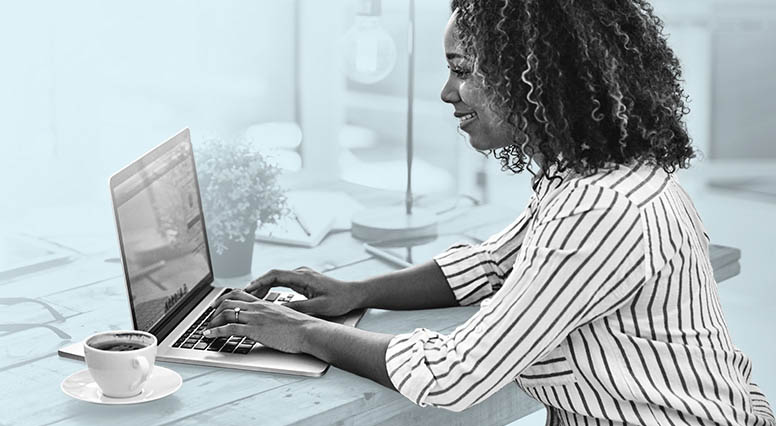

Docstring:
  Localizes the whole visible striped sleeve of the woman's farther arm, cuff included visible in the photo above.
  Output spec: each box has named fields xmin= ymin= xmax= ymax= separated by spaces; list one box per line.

xmin=434 ymin=206 xmax=531 ymax=306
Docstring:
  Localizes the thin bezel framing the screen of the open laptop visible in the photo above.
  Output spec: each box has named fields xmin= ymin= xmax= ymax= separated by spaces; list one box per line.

xmin=110 ymin=128 xmax=213 ymax=341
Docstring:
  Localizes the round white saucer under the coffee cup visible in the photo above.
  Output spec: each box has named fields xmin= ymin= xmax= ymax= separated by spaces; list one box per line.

xmin=60 ymin=365 xmax=183 ymax=405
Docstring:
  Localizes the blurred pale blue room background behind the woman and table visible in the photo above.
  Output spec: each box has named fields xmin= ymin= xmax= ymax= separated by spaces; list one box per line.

xmin=0 ymin=0 xmax=776 ymax=420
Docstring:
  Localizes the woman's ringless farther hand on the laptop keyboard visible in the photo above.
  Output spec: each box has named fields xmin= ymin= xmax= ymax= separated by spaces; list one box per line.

xmin=245 ymin=266 xmax=361 ymax=317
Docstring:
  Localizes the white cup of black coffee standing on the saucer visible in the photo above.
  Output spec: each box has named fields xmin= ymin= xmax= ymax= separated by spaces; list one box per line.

xmin=84 ymin=330 xmax=157 ymax=398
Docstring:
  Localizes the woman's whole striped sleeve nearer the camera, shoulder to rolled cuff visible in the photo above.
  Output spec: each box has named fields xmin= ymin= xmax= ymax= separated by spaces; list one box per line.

xmin=386 ymin=185 xmax=647 ymax=411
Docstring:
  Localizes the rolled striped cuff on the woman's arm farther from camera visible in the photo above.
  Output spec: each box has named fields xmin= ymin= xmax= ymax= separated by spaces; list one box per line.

xmin=434 ymin=245 xmax=502 ymax=306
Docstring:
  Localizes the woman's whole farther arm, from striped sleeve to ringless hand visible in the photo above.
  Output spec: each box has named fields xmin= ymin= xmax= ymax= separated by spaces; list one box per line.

xmin=245 ymin=205 xmax=531 ymax=316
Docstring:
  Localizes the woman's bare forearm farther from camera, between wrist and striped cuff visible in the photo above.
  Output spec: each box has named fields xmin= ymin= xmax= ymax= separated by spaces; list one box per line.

xmin=356 ymin=261 xmax=458 ymax=310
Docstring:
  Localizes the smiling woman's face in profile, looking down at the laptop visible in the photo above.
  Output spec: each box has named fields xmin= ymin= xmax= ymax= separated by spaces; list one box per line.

xmin=441 ymin=11 xmax=513 ymax=151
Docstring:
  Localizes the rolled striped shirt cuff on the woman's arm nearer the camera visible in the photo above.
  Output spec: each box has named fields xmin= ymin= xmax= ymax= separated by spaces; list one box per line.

xmin=385 ymin=328 xmax=440 ymax=407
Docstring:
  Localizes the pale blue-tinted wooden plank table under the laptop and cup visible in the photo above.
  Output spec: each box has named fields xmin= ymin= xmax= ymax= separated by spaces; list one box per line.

xmin=0 ymin=201 xmax=740 ymax=425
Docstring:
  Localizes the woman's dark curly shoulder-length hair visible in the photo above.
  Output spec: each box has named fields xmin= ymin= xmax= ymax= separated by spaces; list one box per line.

xmin=451 ymin=0 xmax=695 ymax=179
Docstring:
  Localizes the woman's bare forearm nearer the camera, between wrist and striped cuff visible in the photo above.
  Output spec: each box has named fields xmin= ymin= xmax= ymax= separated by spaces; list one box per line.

xmin=303 ymin=319 xmax=395 ymax=390
